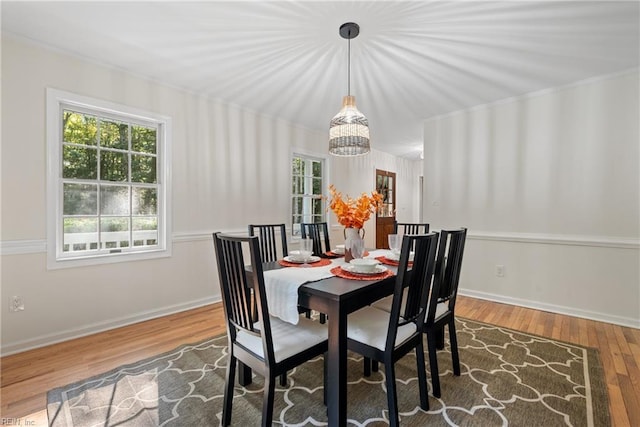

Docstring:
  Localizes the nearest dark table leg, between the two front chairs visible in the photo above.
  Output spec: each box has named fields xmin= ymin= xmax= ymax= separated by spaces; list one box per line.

xmin=327 ymin=307 xmax=347 ymax=427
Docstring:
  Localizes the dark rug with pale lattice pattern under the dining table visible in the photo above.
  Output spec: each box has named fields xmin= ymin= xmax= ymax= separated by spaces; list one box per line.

xmin=47 ymin=319 xmax=610 ymax=427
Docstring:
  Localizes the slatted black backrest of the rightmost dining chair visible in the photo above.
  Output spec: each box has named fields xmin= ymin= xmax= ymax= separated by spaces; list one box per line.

xmin=427 ymin=228 xmax=467 ymax=323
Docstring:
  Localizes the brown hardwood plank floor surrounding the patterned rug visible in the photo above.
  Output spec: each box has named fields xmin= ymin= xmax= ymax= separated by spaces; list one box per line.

xmin=0 ymin=297 xmax=640 ymax=427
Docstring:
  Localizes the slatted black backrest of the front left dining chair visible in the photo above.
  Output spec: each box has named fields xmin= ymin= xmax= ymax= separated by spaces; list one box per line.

xmin=213 ymin=233 xmax=274 ymax=361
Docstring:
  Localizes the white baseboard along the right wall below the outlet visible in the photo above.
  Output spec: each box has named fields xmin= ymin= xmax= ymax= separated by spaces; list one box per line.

xmin=458 ymin=288 xmax=640 ymax=329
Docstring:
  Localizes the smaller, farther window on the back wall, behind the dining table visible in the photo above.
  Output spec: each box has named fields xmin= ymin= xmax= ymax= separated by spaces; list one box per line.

xmin=291 ymin=154 xmax=327 ymax=236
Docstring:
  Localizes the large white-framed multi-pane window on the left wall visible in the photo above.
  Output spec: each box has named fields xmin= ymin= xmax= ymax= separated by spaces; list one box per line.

xmin=47 ymin=89 xmax=171 ymax=268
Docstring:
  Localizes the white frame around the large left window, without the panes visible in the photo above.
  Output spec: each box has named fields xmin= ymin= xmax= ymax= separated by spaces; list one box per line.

xmin=46 ymin=88 xmax=172 ymax=269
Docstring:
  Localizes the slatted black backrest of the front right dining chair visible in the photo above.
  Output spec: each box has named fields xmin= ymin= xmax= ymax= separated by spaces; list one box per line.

xmin=387 ymin=233 xmax=438 ymax=352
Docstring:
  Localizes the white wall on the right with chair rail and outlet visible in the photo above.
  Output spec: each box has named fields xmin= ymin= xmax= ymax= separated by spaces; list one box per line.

xmin=424 ymin=70 xmax=640 ymax=327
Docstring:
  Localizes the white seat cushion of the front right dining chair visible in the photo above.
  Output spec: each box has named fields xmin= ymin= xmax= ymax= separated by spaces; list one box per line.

xmin=347 ymin=307 xmax=416 ymax=351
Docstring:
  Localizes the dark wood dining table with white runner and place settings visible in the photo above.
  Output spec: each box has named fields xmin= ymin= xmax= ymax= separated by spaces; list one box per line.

xmin=238 ymin=250 xmax=397 ymax=427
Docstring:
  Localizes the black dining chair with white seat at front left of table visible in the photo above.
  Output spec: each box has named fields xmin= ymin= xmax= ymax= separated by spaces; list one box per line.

xmin=213 ymin=233 xmax=328 ymax=427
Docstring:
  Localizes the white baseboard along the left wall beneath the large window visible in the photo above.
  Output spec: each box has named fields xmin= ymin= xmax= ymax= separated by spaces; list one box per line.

xmin=0 ymin=297 xmax=221 ymax=357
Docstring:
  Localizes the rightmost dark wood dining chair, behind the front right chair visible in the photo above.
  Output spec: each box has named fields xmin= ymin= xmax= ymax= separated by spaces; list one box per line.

xmin=422 ymin=228 xmax=467 ymax=397
